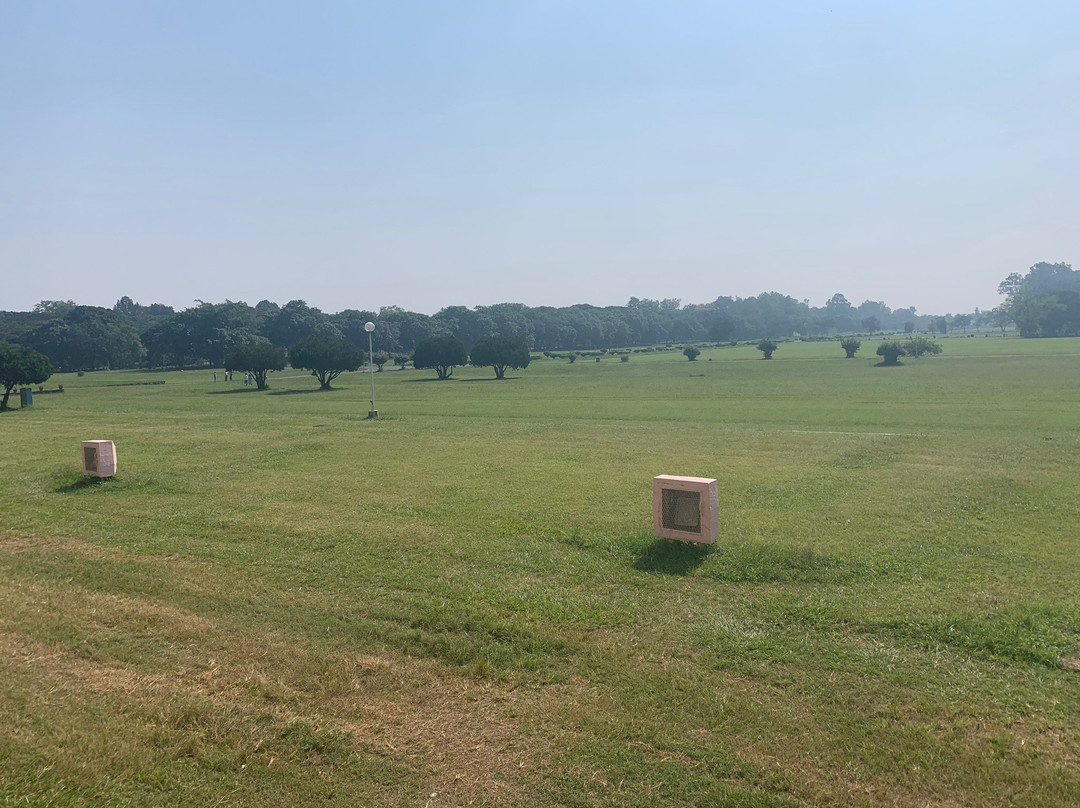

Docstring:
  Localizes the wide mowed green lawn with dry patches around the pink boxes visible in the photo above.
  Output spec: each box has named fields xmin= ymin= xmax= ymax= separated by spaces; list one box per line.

xmin=0 ymin=336 xmax=1080 ymax=807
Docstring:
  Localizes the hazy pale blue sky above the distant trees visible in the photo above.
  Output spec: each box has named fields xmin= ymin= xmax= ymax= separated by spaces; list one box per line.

xmin=0 ymin=0 xmax=1080 ymax=314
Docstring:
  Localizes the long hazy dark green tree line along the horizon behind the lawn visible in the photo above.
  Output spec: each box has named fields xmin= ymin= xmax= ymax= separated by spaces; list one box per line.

xmin=0 ymin=264 xmax=1080 ymax=371
